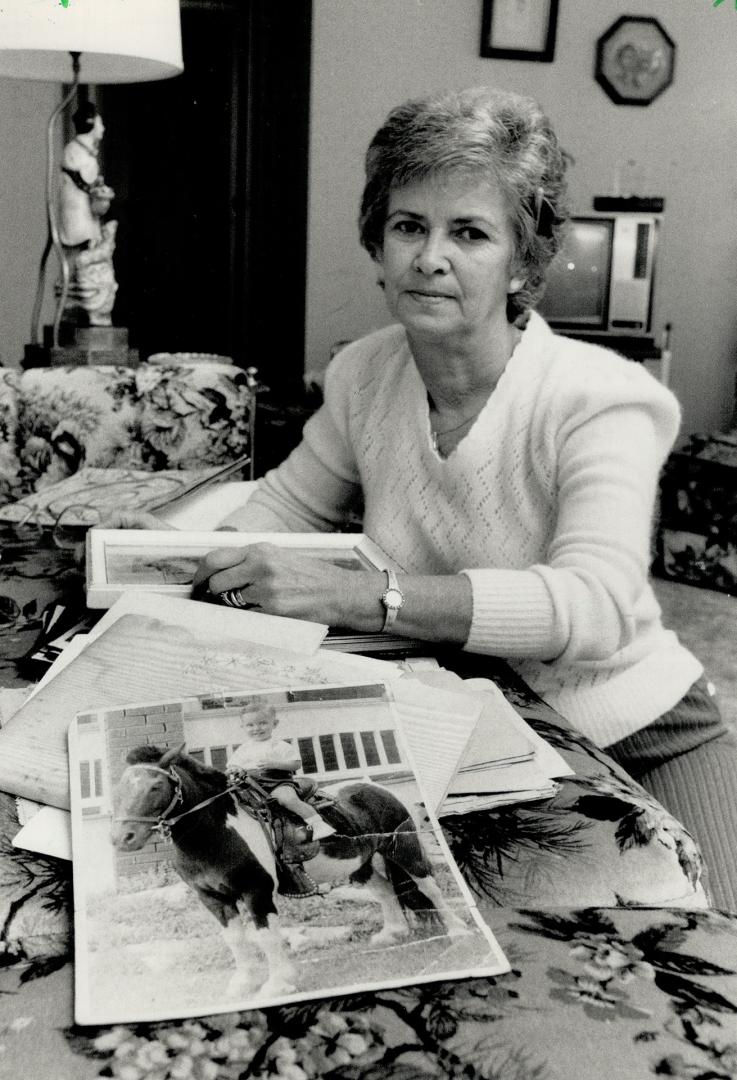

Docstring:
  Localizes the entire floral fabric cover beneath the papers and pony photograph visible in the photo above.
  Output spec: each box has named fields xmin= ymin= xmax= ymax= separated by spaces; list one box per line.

xmin=0 ymin=527 xmax=737 ymax=1080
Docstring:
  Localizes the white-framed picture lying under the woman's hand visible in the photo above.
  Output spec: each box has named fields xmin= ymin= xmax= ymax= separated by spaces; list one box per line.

xmin=85 ymin=529 xmax=401 ymax=608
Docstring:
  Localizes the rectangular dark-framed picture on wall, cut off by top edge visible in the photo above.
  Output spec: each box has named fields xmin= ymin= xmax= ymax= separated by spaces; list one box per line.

xmin=481 ymin=0 xmax=558 ymax=64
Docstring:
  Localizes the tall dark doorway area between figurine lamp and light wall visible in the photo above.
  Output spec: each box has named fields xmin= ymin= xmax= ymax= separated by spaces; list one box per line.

xmin=95 ymin=0 xmax=311 ymax=390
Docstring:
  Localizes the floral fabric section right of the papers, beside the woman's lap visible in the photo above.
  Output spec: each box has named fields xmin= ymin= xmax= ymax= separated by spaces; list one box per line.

xmin=434 ymin=653 xmax=709 ymax=917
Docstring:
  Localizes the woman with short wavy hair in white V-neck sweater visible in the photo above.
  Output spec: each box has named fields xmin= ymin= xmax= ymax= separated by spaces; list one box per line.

xmin=135 ymin=89 xmax=737 ymax=906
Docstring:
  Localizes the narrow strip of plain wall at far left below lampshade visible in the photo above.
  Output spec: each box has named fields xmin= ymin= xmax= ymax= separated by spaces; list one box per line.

xmin=0 ymin=79 xmax=61 ymax=367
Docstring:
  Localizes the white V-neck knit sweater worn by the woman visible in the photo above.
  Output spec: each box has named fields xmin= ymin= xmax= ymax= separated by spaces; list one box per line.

xmin=228 ymin=313 xmax=702 ymax=746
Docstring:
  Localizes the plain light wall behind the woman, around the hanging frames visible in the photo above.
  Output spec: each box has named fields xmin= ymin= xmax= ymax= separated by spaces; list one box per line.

xmin=306 ymin=0 xmax=737 ymax=431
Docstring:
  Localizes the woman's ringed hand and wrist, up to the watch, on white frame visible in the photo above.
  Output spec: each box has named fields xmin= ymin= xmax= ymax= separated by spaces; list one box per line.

xmin=193 ymin=543 xmax=383 ymax=629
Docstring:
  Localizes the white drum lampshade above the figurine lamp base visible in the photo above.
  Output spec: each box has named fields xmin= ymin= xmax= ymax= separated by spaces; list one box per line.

xmin=0 ymin=0 xmax=184 ymax=83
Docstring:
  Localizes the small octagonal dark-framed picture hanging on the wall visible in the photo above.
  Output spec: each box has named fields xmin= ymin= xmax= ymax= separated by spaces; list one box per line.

xmin=595 ymin=15 xmax=675 ymax=105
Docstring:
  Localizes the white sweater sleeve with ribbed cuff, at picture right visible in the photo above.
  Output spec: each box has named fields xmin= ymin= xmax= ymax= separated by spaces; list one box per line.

xmin=463 ymin=383 xmax=679 ymax=662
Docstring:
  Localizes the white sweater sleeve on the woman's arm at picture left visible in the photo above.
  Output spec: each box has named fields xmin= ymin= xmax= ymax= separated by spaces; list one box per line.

xmin=222 ymin=357 xmax=361 ymax=532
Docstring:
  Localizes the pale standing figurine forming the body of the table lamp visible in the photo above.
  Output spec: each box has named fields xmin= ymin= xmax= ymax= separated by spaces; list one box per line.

xmin=57 ymin=102 xmax=118 ymax=326
